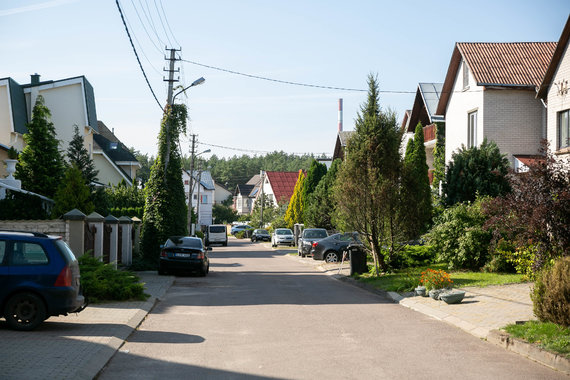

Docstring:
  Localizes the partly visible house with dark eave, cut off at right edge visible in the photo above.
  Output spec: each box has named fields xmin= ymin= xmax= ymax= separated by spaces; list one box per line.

xmin=537 ymin=17 xmax=570 ymax=158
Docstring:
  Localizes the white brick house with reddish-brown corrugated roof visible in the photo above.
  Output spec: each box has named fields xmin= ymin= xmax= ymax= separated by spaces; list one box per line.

xmin=435 ymin=42 xmax=556 ymax=167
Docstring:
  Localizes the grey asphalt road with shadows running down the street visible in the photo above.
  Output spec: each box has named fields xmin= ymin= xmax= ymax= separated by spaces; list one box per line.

xmin=99 ymin=240 xmax=568 ymax=380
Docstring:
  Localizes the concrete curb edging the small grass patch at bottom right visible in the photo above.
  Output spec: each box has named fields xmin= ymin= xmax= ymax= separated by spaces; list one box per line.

xmin=487 ymin=330 xmax=570 ymax=375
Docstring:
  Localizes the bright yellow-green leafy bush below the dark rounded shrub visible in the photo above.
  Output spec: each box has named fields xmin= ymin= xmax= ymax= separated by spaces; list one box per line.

xmin=425 ymin=198 xmax=491 ymax=269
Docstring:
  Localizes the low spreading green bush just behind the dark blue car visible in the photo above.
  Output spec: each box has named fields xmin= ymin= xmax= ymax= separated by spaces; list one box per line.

xmin=78 ymin=255 xmax=149 ymax=303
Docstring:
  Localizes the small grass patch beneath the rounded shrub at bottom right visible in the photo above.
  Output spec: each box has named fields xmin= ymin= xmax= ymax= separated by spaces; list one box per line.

xmin=504 ymin=321 xmax=570 ymax=359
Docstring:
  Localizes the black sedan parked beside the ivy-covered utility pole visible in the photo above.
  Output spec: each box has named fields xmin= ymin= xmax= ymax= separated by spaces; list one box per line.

xmin=158 ymin=236 xmax=212 ymax=276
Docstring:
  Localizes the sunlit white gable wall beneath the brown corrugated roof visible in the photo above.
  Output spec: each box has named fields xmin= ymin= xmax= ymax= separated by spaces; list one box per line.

xmin=445 ymin=63 xmax=484 ymax=164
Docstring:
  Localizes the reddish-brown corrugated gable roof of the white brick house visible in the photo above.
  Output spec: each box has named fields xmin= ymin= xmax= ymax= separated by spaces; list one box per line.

xmin=436 ymin=42 xmax=556 ymax=115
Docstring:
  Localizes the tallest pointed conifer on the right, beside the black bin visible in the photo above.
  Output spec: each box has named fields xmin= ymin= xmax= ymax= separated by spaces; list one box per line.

xmin=334 ymin=75 xmax=402 ymax=276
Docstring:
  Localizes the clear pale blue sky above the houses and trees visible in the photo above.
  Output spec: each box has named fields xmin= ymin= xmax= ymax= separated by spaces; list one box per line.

xmin=0 ymin=0 xmax=570 ymax=156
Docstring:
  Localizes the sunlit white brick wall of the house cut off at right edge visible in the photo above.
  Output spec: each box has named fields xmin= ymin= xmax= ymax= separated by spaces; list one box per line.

xmin=546 ymin=36 xmax=570 ymax=157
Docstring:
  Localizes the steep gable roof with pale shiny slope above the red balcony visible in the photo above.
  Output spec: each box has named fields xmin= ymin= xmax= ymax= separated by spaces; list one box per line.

xmin=405 ymin=83 xmax=444 ymax=132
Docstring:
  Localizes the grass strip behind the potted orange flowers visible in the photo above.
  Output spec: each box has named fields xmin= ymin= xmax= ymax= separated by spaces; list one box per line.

xmin=357 ymin=264 xmax=522 ymax=292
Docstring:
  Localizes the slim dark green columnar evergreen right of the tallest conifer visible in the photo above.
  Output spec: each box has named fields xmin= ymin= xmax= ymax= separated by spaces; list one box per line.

xmin=400 ymin=123 xmax=432 ymax=239
